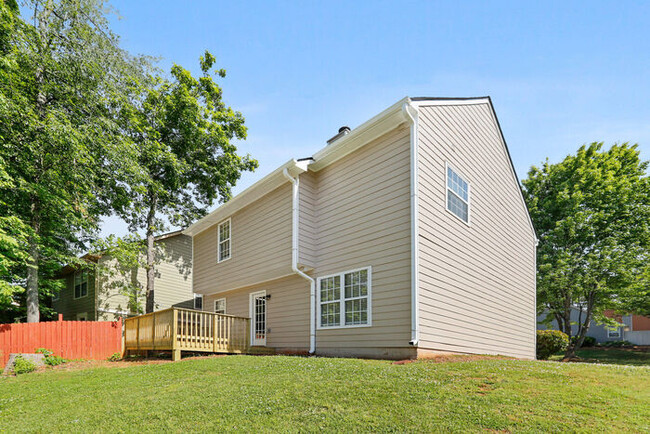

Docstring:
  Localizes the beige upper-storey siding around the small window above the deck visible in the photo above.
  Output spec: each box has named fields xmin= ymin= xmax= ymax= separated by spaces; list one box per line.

xmin=194 ymin=182 xmax=292 ymax=294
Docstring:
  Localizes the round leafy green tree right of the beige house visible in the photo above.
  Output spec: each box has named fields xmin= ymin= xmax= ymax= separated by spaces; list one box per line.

xmin=523 ymin=143 xmax=650 ymax=358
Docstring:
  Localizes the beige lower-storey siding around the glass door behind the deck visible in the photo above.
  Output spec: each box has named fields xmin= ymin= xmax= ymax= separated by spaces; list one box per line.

xmin=203 ymin=276 xmax=309 ymax=351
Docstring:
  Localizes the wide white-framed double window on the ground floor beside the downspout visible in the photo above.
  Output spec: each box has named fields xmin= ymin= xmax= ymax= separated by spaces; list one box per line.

xmin=318 ymin=267 xmax=371 ymax=328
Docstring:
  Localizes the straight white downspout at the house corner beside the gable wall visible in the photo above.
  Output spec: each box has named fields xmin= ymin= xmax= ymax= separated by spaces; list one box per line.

xmin=402 ymin=101 xmax=420 ymax=346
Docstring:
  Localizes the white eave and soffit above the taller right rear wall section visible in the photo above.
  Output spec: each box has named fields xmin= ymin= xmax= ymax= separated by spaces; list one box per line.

xmin=309 ymin=97 xmax=410 ymax=172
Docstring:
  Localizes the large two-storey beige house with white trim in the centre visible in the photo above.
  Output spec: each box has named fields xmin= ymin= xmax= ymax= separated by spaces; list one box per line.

xmin=184 ymin=97 xmax=537 ymax=359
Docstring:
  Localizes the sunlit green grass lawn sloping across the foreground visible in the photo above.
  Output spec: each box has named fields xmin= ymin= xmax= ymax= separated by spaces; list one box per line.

xmin=0 ymin=356 xmax=650 ymax=432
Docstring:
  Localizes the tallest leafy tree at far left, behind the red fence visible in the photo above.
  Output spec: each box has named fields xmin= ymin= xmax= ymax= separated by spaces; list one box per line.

xmin=0 ymin=0 xmax=142 ymax=322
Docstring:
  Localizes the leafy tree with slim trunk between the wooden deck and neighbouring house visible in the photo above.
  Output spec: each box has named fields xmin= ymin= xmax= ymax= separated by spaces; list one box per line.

xmin=117 ymin=51 xmax=257 ymax=312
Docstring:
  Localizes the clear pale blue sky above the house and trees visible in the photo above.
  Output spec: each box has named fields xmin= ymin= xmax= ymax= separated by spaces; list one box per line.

xmin=103 ymin=0 xmax=650 ymax=235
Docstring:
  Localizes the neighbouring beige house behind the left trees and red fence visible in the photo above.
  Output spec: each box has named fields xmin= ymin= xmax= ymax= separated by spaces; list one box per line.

xmin=53 ymin=231 xmax=192 ymax=321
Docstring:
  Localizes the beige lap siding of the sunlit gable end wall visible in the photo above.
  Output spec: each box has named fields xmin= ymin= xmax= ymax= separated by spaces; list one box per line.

xmin=418 ymin=103 xmax=535 ymax=358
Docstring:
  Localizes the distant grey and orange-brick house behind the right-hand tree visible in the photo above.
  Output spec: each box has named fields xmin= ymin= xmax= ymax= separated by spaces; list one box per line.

xmin=537 ymin=308 xmax=650 ymax=345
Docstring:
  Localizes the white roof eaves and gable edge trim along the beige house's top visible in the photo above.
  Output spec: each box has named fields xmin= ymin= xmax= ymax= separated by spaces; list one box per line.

xmin=183 ymin=96 xmax=537 ymax=238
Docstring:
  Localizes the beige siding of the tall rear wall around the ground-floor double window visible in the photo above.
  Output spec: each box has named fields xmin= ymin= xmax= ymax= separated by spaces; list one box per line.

xmin=315 ymin=124 xmax=411 ymax=350
